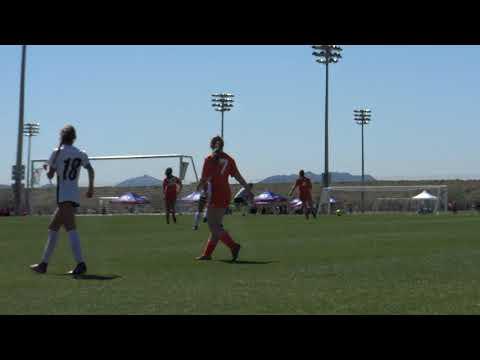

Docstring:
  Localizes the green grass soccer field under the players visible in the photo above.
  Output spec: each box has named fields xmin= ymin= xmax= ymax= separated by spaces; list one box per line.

xmin=0 ymin=214 xmax=480 ymax=314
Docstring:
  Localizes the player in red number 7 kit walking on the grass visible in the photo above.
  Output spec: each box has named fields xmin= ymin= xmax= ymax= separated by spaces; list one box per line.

xmin=197 ymin=136 xmax=253 ymax=261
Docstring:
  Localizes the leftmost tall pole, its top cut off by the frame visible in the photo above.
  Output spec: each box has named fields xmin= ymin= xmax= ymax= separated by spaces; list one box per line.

xmin=13 ymin=45 xmax=27 ymax=216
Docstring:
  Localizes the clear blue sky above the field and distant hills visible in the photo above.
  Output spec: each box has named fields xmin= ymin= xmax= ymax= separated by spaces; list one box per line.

xmin=0 ymin=46 xmax=480 ymax=184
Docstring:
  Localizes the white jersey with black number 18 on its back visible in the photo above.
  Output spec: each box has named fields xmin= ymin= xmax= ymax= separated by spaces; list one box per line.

xmin=48 ymin=145 xmax=90 ymax=206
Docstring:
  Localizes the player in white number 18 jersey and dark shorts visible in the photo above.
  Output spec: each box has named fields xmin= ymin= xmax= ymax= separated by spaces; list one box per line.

xmin=30 ymin=125 xmax=95 ymax=275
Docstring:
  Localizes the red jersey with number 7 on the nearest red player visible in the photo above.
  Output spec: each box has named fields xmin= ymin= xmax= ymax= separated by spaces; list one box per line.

xmin=202 ymin=152 xmax=238 ymax=209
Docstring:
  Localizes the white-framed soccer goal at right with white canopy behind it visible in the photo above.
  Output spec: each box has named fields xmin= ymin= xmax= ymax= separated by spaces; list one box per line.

xmin=318 ymin=185 xmax=448 ymax=214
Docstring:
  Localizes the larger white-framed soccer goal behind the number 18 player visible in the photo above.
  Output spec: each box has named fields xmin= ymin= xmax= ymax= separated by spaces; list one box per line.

xmin=28 ymin=154 xmax=198 ymax=215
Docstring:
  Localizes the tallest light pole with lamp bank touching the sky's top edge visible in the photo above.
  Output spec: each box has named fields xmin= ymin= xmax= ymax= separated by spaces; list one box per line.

xmin=312 ymin=45 xmax=343 ymax=188
